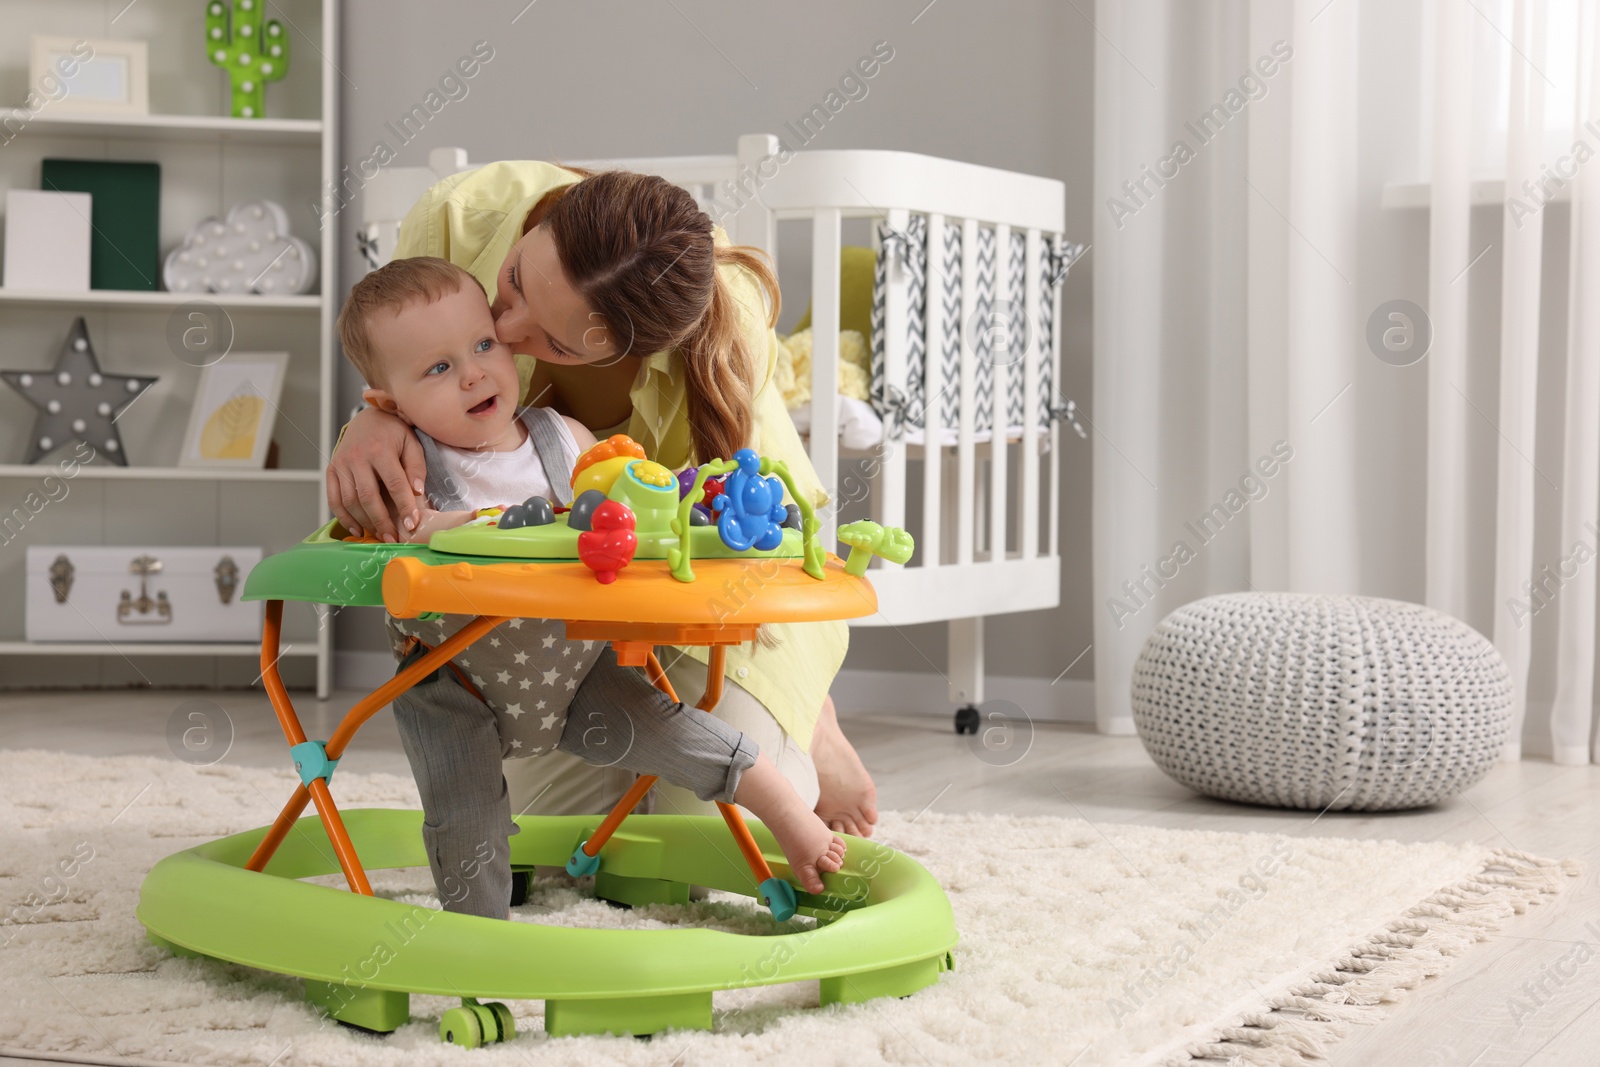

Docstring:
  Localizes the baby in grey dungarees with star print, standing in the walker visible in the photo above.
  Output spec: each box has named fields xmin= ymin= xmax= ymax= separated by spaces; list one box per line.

xmin=339 ymin=256 xmax=845 ymax=918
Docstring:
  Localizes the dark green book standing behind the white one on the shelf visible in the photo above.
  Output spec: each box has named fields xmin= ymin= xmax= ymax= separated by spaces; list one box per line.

xmin=38 ymin=160 xmax=162 ymax=290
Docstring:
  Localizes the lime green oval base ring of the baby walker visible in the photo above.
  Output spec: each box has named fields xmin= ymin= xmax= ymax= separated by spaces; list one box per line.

xmin=138 ymin=808 xmax=957 ymax=1046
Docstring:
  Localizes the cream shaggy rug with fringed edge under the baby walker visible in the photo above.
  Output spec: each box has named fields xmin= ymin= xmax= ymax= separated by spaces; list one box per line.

xmin=0 ymin=752 xmax=1578 ymax=1067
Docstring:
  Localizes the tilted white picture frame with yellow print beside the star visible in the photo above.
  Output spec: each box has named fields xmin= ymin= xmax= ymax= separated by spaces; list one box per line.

xmin=178 ymin=352 xmax=290 ymax=470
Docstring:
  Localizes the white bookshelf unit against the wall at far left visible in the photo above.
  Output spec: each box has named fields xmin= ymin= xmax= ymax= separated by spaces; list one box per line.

xmin=0 ymin=0 xmax=341 ymax=697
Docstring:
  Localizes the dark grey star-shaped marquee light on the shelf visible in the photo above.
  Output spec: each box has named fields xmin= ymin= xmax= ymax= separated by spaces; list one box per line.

xmin=0 ymin=317 xmax=158 ymax=467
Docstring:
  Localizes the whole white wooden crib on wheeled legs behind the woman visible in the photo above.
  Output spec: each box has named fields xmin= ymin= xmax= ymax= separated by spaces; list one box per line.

xmin=362 ymin=134 xmax=1083 ymax=733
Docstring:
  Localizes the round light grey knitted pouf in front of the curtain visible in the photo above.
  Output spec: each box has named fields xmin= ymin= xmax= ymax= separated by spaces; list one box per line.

xmin=1133 ymin=593 xmax=1512 ymax=811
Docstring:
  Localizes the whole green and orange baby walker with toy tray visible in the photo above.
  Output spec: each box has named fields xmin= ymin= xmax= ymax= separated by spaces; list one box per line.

xmin=138 ymin=435 xmax=957 ymax=1046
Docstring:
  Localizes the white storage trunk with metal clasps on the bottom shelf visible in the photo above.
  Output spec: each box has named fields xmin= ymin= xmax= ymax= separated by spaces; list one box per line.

xmin=26 ymin=545 xmax=262 ymax=645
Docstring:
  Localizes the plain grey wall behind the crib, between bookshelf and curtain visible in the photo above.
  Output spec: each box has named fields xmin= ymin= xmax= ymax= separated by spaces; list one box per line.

xmin=338 ymin=0 xmax=1094 ymax=694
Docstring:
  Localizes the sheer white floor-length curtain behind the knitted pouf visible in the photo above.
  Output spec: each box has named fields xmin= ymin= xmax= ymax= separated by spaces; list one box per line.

xmin=1090 ymin=0 xmax=1600 ymax=763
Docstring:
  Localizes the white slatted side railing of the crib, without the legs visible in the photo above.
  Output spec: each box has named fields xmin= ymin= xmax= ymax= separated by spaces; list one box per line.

xmin=741 ymin=138 xmax=1066 ymax=648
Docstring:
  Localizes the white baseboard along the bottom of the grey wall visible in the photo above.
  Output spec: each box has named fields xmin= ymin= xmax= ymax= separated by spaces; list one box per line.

xmin=333 ymin=653 xmax=1094 ymax=723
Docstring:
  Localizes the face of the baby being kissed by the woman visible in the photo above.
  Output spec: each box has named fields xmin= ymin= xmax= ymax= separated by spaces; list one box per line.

xmin=368 ymin=282 xmax=518 ymax=450
